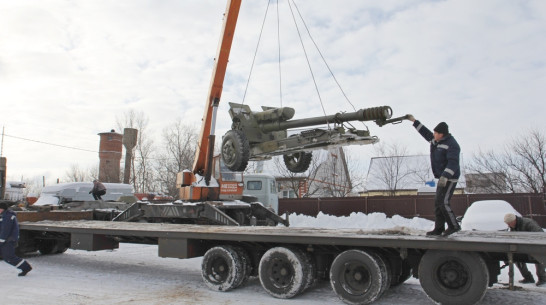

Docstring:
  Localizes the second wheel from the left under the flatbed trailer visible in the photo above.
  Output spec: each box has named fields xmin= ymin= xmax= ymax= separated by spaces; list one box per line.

xmin=258 ymin=247 xmax=313 ymax=299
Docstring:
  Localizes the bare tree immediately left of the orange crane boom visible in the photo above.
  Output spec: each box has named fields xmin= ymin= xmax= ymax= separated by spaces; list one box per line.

xmin=156 ymin=119 xmax=197 ymax=197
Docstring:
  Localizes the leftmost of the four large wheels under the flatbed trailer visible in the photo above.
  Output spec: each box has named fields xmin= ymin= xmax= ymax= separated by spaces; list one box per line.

xmin=201 ymin=246 xmax=244 ymax=291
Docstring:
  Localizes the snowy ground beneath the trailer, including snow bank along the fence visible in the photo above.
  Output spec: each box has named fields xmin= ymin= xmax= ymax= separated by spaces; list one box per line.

xmin=0 ymin=214 xmax=546 ymax=305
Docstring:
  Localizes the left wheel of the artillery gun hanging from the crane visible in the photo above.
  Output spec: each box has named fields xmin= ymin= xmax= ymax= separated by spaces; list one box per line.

xmin=222 ymin=130 xmax=250 ymax=172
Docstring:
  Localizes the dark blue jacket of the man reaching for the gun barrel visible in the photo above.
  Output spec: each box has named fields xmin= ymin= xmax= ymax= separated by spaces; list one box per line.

xmin=413 ymin=120 xmax=461 ymax=179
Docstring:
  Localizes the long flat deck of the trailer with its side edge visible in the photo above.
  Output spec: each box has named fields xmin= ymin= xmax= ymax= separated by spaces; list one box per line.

xmin=20 ymin=220 xmax=546 ymax=255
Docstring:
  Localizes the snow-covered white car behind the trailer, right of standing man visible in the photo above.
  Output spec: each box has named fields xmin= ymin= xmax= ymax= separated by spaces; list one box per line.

xmin=461 ymin=200 xmax=521 ymax=231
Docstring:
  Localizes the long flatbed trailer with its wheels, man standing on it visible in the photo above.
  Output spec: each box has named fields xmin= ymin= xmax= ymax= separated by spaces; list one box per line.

xmin=20 ymin=220 xmax=546 ymax=304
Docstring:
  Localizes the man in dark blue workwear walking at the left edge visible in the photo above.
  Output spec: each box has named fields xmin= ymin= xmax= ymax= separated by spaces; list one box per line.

xmin=0 ymin=200 xmax=32 ymax=276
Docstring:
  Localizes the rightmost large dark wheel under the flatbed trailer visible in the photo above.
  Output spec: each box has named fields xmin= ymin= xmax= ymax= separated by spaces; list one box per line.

xmin=419 ymin=250 xmax=489 ymax=305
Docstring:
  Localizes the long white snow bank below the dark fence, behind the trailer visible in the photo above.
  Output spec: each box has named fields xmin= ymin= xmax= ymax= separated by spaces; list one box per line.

xmin=283 ymin=212 xmax=434 ymax=230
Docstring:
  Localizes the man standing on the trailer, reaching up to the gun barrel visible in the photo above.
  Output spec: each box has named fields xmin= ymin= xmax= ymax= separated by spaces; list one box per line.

xmin=408 ymin=115 xmax=461 ymax=236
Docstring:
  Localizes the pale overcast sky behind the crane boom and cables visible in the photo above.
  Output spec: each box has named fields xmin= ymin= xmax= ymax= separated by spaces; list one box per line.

xmin=0 ymin=0 xmax=546 ymax=183
